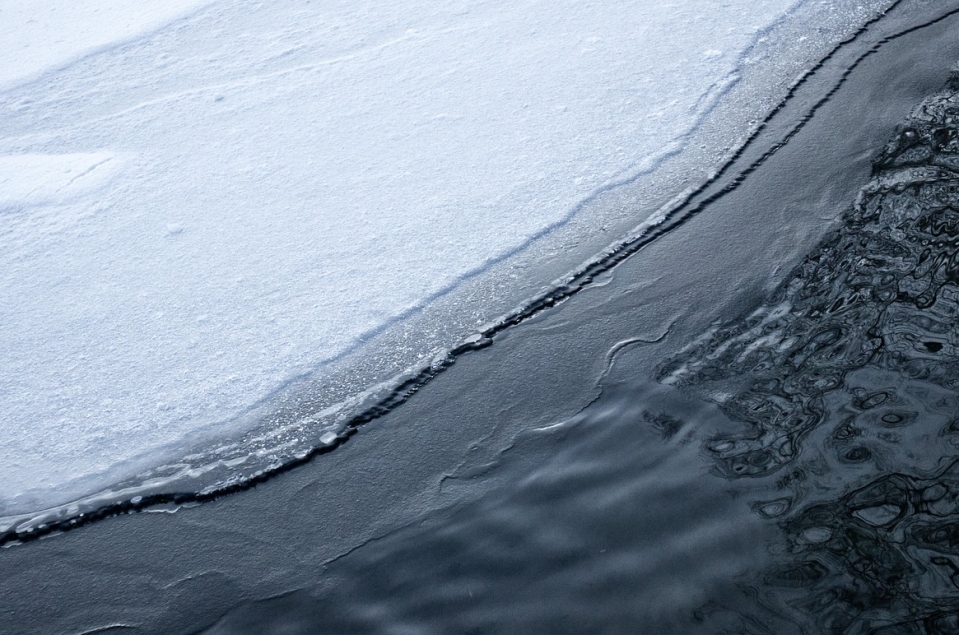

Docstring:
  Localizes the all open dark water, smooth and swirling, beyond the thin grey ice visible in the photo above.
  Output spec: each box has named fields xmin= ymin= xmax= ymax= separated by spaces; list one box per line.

xmin=208 ymin=16 xmax=959 ymax=634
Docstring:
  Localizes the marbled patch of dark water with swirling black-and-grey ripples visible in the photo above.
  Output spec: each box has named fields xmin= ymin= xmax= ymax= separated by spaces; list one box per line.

xmin=658 ymin=78 xmax=959 ymax=635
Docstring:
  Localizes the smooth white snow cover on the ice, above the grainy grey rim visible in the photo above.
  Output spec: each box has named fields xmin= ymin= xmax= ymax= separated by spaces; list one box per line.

xmin=0 ymin=0 xmax=816 ymax=512
